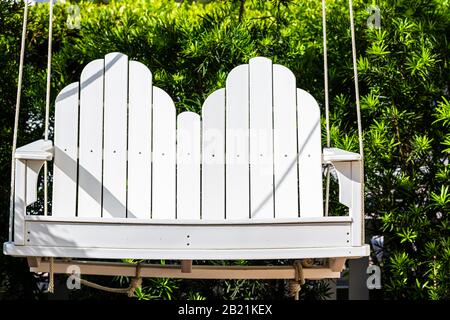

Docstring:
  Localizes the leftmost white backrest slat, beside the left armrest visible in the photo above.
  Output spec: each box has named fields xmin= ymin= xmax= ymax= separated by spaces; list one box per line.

xmin=52 ymin=82 xmax=79 ymax=217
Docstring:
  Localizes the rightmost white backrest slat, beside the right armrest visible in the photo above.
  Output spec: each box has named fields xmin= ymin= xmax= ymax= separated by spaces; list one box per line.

xmin=297 ymin=89 xmax=323 ymax=217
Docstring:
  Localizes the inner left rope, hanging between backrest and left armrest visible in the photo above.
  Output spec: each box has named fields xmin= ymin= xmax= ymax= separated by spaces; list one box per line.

xmin=44 ymin=0 xmax=53 ymax=215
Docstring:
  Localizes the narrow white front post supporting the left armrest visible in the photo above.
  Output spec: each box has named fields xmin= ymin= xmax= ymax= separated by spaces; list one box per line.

xmin=14 ymin=160 xmax=27 ymax=245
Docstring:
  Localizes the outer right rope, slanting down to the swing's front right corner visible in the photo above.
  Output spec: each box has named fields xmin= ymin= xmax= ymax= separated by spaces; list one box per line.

xmin=349 ymin=0 xmax=365 ymax=240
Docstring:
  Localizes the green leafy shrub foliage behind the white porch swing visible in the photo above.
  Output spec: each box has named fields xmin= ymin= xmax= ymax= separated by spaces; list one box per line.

xmin=0 ymin=0 xmax=450 ymax=299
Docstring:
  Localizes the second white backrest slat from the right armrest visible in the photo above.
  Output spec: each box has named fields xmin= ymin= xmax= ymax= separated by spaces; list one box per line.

xmin=273 ymin=64 xmax=299 ymax=218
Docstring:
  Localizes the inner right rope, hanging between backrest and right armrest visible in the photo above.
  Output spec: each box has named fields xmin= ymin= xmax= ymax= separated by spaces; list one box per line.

xmin=322 ymin=0 xmax=331 ymax=216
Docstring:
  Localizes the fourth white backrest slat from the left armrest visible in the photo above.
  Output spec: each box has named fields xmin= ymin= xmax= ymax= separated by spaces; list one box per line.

xmin=127 ymin=61 xmax=152 ymax=219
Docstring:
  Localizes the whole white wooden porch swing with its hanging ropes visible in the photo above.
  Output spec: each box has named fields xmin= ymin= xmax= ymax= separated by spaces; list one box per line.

xmin=4 ymin=0 xmax=369 ymax=296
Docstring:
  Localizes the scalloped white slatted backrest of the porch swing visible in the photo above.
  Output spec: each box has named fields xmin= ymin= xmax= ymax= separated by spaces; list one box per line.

xmin=52 ymin=53 xmax=323 ymax=220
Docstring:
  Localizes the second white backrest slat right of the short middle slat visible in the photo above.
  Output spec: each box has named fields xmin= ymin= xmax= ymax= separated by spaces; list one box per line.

xmin=226 ymin=65 xmax=250 ymax=219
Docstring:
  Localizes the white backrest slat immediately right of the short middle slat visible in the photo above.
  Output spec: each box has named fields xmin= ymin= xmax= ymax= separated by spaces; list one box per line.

xmin=202 ymin=89 xmax=225 ymax=220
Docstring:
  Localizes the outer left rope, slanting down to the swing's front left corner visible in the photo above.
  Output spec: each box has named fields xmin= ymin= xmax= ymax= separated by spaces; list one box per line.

xmin=8 ymin=0 xmax=28 ymax=242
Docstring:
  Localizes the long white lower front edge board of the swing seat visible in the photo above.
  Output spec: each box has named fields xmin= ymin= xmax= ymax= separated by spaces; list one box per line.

xmin=3 ymin=243 xmax=370 ymax=260
